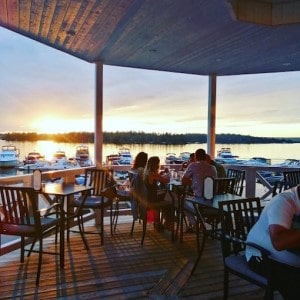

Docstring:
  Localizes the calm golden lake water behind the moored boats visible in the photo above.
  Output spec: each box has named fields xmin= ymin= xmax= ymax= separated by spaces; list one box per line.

xmin=0 ymin=140 xmax=300 ymax=176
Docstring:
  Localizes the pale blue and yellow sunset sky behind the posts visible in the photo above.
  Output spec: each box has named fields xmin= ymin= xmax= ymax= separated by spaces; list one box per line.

xmin=0 ymin=27 xmax=300 ymax=137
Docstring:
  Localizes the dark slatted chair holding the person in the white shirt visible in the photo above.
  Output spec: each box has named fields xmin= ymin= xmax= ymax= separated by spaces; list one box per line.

xmin=219 ymin=198 xmax=273 ymax=299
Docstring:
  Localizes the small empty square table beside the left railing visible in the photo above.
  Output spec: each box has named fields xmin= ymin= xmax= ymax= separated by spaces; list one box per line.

xmin=39 ymin=183 xmax=93 ymax=267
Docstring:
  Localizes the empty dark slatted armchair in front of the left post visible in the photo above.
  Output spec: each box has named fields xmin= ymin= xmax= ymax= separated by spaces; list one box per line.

xmin=72 ymin=168 xmax=117 ymax=245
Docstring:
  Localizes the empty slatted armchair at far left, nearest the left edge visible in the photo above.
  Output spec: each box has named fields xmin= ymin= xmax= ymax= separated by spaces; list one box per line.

xmin=0 ymin=186 xmax=64 ymax=285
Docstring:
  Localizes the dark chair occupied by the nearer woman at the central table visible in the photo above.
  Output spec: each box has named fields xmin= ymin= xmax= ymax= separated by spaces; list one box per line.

xmin=131 ymin=174 xmax=175 ymax=245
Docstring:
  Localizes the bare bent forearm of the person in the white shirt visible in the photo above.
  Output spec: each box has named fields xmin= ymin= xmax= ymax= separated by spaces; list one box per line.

xmin=269 ymin=224 xmax=300 ymax=251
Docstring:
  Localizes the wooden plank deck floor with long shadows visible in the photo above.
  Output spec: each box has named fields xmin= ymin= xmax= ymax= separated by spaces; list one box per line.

xmin=0 ymin=218 xmax=281 ymax=300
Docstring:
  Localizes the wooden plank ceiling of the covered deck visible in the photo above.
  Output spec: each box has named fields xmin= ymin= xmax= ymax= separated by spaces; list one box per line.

xmin=0 ymin=0 xmax=300 ymax=76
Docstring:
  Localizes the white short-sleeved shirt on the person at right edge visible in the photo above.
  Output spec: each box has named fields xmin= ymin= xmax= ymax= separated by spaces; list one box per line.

xmin=246 ymin=187 xmax=300 ymax=267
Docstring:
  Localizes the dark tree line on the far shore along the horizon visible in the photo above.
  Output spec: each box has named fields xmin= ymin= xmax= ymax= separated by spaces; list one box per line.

xmin=0 ymin=131 xmax=300 ymax=145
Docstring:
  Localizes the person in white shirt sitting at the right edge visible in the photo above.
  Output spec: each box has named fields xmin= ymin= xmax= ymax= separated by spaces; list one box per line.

xmin=246 ymin=185 xmax=300 ymax=299
